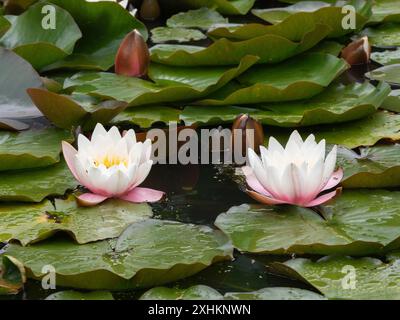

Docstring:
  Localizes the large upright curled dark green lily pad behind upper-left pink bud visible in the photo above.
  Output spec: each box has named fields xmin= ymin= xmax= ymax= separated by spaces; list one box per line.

xmin=41 ymin=0 xmax=147 ymax=71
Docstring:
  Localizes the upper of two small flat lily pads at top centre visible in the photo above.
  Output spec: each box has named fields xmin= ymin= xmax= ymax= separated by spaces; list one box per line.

xmin=167 ymin=7 xmax=229 ymax=30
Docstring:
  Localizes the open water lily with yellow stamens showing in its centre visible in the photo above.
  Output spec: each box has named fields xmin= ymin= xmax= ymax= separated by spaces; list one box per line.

xmin=62 ymin=124 xmax=164 ymax=206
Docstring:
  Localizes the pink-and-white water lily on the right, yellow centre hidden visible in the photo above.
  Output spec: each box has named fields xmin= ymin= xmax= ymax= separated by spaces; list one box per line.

xmin=243 ymin=131 xmax=343 ymax=207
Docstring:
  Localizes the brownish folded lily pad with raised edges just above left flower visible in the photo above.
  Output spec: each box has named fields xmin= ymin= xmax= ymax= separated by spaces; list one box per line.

xmin=28 ymin=89 xmax=126 ymax=130
